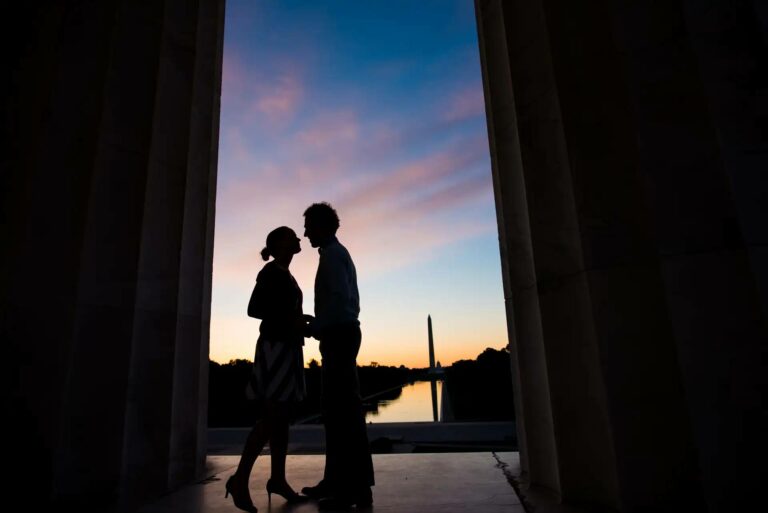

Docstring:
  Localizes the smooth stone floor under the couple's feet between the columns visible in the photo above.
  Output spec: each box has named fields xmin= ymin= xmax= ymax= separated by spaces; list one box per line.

xmin=139 ymin=452 xmax=525 ymax=513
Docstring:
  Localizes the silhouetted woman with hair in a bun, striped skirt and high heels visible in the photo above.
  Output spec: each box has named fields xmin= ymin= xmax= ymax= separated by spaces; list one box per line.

xmin=225 ymin=226 xmax=307 ymax=512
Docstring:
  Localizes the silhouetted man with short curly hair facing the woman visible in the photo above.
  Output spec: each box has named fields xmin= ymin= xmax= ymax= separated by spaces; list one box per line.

xmin=302 ymin=203 xmax=374 ymax=509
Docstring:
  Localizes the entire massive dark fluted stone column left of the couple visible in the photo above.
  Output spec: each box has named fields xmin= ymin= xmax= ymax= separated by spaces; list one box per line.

xmin=0 ymin=0 xmax=224 ymax=511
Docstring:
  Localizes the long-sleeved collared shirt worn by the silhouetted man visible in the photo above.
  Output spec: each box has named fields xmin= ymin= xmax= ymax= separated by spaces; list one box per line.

xmin=312 ymin=237 xmax=360 ymax=332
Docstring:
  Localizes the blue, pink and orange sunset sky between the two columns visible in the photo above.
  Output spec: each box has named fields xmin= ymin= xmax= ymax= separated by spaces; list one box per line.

xmin=210 ymin=0 xmax=507 ymax=367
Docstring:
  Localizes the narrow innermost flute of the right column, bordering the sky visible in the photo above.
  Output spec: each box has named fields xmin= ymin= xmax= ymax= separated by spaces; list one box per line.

xmin=476 ymin=1 xmax=560 ymax=495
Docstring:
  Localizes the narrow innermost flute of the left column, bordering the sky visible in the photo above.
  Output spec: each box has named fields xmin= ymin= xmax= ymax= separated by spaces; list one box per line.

xmin=169 ymin=0 xmax=224 ymax=486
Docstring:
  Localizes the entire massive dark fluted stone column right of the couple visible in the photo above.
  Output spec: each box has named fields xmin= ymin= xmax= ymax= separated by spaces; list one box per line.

xmin=476 ymin=0 xmax=768 ymax=511
